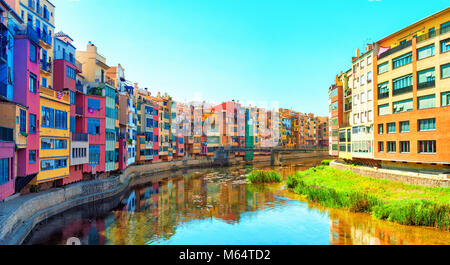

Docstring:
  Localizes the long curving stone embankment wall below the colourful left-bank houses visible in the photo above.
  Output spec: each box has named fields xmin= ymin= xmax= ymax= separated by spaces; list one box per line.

xmin=0 ymin=152 xmax=326 ymax=245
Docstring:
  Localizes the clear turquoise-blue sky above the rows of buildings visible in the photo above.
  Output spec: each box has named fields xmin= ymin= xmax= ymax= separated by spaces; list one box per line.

xmin=51 ymin=0 xmax=449 ymax=115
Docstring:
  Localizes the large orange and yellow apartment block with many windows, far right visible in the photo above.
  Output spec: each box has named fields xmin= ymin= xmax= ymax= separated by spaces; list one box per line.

xmin=373 ymin=8 xmax=450 ymax=168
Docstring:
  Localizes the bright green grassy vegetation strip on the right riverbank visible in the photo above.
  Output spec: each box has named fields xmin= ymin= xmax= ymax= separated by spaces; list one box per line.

xmin=287 ymin=166 xmax=450 ymax=231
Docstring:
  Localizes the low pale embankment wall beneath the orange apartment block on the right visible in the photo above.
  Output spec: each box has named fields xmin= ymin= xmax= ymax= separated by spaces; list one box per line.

xmin=330 ymin=161 xmax=450 ymax=187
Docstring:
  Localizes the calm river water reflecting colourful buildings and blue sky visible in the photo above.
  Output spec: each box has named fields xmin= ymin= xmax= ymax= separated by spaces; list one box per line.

xmin=24 ymin=160 xmax=450 ymax=245
